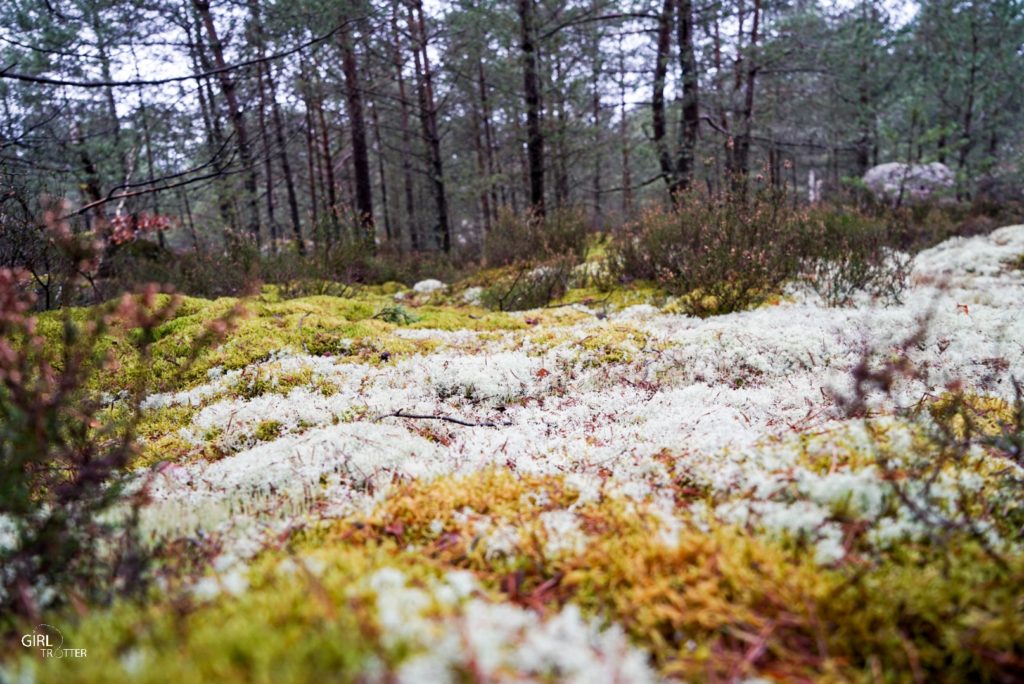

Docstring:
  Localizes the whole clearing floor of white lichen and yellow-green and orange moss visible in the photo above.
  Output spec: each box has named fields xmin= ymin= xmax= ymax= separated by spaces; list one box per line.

xmin=6 ymin=226 xmax=1024 ymax=683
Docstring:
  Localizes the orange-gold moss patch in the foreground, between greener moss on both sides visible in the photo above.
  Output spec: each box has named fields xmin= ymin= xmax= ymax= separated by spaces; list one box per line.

xmin=344 ymin=471 xmax=840 ymax=679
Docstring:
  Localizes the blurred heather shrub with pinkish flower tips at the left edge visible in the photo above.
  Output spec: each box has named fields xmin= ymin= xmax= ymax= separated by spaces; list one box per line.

xmin=0 ymin=215 xmax=234 ymax=631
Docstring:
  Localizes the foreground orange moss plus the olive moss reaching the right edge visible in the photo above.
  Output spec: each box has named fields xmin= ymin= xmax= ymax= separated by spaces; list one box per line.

xmin=348 ymin=471 xmax=1024 ymax=681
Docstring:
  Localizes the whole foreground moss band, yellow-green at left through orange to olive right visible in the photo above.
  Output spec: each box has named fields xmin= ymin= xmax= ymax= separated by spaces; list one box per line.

xmin=9 ymin=471 xmax=1024 ymax=682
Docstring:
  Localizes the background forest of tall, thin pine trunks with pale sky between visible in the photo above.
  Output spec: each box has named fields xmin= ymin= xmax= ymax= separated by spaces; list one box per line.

xmin=0 ymin=0 xmax=1024 ymax=305
